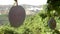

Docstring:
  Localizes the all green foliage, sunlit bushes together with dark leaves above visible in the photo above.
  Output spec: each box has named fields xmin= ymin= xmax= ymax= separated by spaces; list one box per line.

xmin=0 ymin=0 xmax=60 ymax=34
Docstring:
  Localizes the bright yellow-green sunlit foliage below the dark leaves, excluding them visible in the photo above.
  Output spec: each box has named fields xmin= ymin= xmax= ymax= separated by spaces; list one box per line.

xmin=0 ymin=11 xmax=60 ymax=34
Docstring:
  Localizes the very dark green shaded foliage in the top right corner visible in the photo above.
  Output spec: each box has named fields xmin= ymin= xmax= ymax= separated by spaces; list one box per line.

xmin=47 ymin=0 xmax=60 ymax=15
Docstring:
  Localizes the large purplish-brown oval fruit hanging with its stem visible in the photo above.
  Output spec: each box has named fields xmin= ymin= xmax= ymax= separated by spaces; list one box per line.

xmin=9 ymin=0 xmax=26 ymax=27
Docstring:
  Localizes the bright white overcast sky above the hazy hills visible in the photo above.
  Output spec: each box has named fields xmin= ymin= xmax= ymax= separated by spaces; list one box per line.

xmin=0 ymin=0 xmax=47 ymax=5
